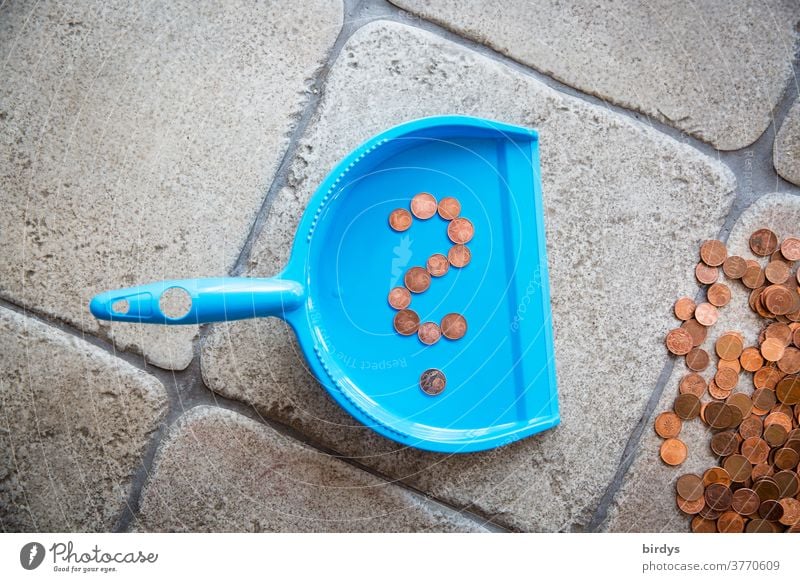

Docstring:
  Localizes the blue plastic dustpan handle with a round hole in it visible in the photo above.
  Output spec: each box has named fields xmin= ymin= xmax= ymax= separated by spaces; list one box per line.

xmin=89 ymin=277 xmax=305 ymax=325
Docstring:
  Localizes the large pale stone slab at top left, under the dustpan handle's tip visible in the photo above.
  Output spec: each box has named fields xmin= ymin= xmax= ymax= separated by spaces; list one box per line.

xmin=0 ymin=0 xmax=342 ymax=369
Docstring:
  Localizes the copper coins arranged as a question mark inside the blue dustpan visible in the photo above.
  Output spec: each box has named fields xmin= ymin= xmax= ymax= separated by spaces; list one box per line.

xmin=389 ymin=192 xmax=475 ymax=396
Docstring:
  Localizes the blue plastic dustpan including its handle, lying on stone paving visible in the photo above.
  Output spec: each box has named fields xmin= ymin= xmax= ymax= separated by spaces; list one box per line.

xmin=90 ymin=116 xmax=559 ymax=452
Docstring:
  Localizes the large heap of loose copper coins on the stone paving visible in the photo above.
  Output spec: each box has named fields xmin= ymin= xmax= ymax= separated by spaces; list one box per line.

xmin=655 ymin=228 xmax=800 ymax=533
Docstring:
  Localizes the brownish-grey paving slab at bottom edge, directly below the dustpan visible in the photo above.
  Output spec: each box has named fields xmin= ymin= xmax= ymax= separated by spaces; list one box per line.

xmin=135 ymin=406 xmax=485 ymax=532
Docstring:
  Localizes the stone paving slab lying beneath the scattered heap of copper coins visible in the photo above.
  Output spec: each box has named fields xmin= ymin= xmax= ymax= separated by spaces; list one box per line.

xmin=602 ymin=194 xmax=800 ymax=532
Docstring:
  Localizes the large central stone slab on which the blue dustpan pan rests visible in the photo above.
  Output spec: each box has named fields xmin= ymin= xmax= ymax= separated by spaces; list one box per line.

xmin=202 ymin=22 xmax=734 ymax=531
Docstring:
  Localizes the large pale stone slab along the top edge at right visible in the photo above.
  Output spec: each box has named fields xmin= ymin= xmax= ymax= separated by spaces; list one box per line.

xmin=391 ymin=0 xmax=800 ymax=150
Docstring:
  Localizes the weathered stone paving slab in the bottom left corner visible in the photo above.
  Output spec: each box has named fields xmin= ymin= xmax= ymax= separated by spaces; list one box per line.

xmin=0 ymin=308 xmax=167 ymax=531
